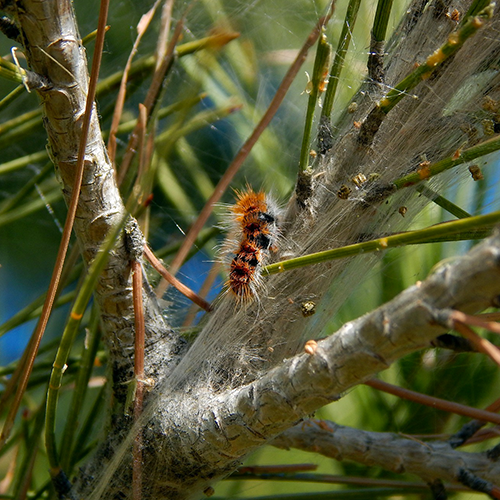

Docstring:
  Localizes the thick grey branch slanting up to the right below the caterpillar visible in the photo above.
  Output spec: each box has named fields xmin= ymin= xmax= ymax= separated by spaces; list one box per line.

xmin=83 ymin=231 xmax=500 ymax=499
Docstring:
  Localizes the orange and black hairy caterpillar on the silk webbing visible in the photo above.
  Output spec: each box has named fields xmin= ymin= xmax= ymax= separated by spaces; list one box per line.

xmin=227 ymin=186 xmax=279 ymax=301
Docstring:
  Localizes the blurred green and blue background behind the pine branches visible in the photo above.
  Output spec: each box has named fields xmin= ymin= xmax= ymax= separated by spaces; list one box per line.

xmin=0 ymin=0 xmax=499 ymax=499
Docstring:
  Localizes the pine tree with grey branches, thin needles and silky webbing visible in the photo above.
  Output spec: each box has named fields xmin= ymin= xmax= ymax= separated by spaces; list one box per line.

xmin=0 ymin=0 xmax=500 ymax=499
